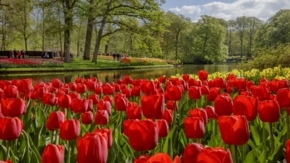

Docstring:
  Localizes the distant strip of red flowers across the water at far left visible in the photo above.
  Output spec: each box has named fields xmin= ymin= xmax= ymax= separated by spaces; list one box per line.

xmin=0 ymin=58 xmax=63 ymax=68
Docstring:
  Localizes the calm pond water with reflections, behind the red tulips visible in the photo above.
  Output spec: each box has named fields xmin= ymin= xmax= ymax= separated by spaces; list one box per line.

xmin=0 ymin=64 xmax=237 ymax=83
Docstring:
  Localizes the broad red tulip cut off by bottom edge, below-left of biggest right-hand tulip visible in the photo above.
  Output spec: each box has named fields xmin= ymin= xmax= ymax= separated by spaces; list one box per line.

xmin=197 ymin=147 xmax=233 ymax=163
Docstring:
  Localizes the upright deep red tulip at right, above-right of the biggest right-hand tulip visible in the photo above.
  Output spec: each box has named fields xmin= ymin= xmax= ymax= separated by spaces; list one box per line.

xmin=259 ymin=100 xmax=280 ymax=122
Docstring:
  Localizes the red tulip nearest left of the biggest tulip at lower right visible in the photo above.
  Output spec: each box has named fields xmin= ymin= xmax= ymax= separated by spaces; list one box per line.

xmin=184 ymin=117 xmax=205 ymax=139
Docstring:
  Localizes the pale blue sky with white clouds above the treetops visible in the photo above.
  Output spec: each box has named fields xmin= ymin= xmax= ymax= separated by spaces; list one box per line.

xmin=161 ymin=0 xmax=290 ymax=22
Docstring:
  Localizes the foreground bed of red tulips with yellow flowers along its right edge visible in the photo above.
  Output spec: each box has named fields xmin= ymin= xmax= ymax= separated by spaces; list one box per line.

xmin=0 ymin=67 xmax=290 ymax=163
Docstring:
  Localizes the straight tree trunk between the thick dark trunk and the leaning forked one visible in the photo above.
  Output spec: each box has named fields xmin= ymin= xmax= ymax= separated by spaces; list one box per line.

xmin=84 ymin=0 xmax=95 ymax=60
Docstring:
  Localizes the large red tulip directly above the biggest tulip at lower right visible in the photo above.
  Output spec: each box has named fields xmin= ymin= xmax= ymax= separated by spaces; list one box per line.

xmin=233 ymin=95 xmax=258 ymax=121
